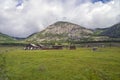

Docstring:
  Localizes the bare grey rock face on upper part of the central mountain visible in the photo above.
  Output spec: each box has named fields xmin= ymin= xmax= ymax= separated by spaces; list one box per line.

xmin=43 ymin=22 xmax=93 ymax=35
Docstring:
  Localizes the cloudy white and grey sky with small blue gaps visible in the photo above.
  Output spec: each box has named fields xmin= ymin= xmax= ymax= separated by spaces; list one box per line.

xmin=0 ymin=0 xmax=120 ymax=37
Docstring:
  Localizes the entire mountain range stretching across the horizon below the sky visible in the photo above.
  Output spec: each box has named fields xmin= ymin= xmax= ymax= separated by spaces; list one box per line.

xmin=0 ymin=21 xmax=120 ymax=43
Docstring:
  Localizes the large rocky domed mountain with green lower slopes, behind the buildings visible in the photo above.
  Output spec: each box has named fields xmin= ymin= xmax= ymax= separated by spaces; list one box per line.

xmin=26 ymin=21 xmax=93 ymax=42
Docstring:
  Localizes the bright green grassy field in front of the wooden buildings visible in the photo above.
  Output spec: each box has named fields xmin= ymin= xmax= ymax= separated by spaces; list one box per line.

xmin=0 ymin=47 xmax=120 ymax=80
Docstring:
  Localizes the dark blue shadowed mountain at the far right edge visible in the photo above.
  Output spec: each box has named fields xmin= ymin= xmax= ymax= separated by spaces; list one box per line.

xmin=99 ymin=23 xmax=120 ymax=38
